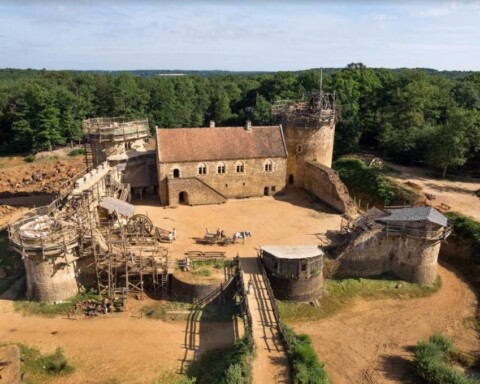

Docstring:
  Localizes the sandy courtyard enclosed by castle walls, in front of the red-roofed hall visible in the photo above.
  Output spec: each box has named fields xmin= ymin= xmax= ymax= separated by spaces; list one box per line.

xmin=135 ymin=189 xmax=341 ymax=258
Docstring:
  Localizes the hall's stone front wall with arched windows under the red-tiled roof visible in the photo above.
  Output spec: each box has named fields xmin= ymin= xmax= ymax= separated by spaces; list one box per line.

xmin=157 ymin=158 xmax=286 ymax=205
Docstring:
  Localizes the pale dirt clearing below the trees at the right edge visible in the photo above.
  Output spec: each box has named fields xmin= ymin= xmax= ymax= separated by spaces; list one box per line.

xmin=389 ymin=164 xmax=480 ymax=221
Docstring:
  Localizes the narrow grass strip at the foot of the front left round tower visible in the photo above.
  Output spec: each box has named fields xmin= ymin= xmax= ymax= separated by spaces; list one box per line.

xmin=14 ymin=292 xmax=102 ymax=317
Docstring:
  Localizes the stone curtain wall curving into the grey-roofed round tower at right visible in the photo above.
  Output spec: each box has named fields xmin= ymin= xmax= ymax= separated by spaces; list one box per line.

xmin=335 ymin=228 xmax=440 ymax=285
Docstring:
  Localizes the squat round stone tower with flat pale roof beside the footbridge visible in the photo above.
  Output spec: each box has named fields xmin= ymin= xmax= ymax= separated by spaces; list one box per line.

xmin=259 ymin=245 xmax=324 ymax=301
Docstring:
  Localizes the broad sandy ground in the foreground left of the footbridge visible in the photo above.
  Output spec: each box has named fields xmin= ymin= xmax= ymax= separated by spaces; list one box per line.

xmin=0 ymin=300 xmax=232 ymax=384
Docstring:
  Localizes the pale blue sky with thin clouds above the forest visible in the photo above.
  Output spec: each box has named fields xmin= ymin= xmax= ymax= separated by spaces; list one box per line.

xmin=0 ymin=0 xmax=480 ymax=71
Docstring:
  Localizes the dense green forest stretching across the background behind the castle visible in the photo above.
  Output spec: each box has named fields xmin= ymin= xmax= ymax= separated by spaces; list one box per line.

xmin=0 ymin=64 xmax=480 ymax=176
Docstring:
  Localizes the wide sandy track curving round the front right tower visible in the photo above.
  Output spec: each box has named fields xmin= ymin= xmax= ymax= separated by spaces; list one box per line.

xmin=294 ymin=267 xmax=480 ymax=384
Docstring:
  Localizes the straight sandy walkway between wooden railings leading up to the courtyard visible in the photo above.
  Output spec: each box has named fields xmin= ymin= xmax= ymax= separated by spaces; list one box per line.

xmin=241 ymin=257 xmax=289 ymax=384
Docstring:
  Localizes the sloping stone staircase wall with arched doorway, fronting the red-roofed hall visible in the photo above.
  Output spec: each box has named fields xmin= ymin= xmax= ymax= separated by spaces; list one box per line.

xmin=168 ymin=177 xmax=227 ymax=205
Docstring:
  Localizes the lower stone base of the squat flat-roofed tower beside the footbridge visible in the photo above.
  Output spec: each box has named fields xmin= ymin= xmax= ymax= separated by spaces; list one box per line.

xmin=267 ymin=271 xmax=324 ymax=301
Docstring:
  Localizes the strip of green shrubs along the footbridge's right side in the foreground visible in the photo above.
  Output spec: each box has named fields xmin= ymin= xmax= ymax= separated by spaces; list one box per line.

xmin=280 ymin=323 xmax=330 ymax=384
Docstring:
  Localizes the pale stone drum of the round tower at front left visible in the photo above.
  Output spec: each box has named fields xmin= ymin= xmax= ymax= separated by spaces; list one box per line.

xmin=23 ymin=254 xmax=78 ymax=303
